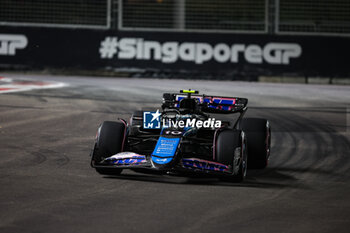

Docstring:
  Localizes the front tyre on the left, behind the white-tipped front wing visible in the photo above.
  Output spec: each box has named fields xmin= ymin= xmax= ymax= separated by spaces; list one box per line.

xmin=92 ymin=121 xmax=125 ymax=175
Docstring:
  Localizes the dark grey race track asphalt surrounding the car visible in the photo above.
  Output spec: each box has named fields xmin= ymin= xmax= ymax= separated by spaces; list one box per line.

xmin=0 ymin=74 xmax=350 ymax=233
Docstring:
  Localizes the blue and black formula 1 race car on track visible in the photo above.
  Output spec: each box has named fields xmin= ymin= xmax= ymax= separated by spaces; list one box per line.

xmin=91 ymin=90 xmax=271 ymax=182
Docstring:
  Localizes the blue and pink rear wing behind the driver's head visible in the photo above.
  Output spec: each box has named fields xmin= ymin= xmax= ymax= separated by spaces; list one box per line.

xmin=162 ymin=93 xmax=248 ymax=113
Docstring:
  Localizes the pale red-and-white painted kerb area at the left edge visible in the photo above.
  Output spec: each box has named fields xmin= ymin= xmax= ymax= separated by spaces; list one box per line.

xmin=0 ymin=77 xmax=68 ymax=94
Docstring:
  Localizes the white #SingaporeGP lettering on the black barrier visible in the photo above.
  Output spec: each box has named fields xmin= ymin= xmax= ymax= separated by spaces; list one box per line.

xmin=99 ymin=37 xmax=302 ymax=65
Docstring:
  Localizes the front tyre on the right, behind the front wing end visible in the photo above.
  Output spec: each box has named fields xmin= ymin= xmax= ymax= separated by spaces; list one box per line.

xmin=216 ymin=129 xmax=247 ymax=182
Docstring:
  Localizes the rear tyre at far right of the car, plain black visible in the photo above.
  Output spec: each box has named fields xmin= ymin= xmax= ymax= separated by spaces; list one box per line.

xmin=240 ymin=118 xmax=271 ymax=168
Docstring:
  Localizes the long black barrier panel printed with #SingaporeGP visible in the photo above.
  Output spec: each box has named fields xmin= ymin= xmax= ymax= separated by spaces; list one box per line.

xmin=0 ymin=27 xmax=350 ymax=76
